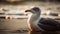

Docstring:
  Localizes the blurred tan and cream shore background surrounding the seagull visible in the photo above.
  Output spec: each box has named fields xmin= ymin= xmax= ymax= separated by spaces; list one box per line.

xmin=0 ymin=0 xmax=60 ymax=31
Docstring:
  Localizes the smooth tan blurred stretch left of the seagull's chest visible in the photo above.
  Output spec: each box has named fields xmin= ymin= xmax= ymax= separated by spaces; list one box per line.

xmin=0 ymin=18 xmax=28 ymax=30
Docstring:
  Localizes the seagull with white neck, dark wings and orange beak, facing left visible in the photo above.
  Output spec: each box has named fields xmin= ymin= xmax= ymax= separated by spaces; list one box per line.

xmin=25 ymin=7 xmax=60 ymax=31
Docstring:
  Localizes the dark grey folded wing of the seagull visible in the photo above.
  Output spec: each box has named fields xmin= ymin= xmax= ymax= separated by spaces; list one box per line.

xmin=38 ymin=18 xmax=60 ymax=31
